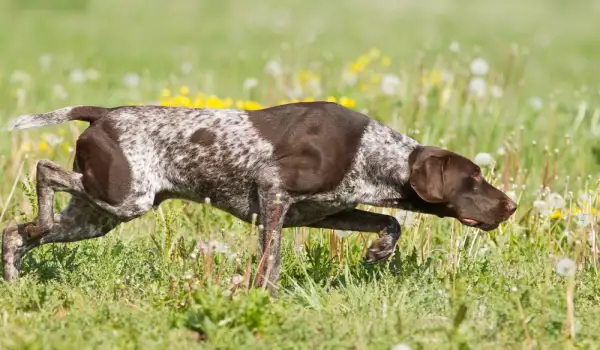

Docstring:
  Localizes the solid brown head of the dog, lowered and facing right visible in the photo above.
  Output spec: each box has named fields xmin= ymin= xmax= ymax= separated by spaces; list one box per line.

xmin=409 ymin=147 xmax=517 ymax=231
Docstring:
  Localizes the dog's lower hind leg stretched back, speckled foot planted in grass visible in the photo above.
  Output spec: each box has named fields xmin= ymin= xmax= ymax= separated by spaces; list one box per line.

xmin=2 ymin=197 xmax=121 ymax=281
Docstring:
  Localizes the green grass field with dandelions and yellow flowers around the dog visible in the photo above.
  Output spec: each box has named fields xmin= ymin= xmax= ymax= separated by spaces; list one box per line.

xmin=0 ymin=0 xmax=600 ymax=349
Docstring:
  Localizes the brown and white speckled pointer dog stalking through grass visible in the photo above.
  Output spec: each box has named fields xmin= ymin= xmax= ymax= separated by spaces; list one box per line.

xmin=2 ymin=102 xmax=516 ymax=287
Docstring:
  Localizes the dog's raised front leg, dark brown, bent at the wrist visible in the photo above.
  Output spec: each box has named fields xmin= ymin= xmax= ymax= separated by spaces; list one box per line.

xmin=306 ymin=209 xmax=400 ymax=263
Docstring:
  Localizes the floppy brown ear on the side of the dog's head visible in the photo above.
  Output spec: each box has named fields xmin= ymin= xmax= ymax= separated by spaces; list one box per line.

xmin=410 ymin=152 xmax=447 ymax=203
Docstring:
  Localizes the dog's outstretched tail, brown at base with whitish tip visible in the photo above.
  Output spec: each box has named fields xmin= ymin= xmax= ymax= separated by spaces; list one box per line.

xmin=9 ymin=106 xmax=111 ymax=130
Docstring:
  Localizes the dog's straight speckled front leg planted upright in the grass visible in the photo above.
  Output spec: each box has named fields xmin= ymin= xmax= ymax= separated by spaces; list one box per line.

xmin=256 ymin=187 xmax=291 ymax=290
